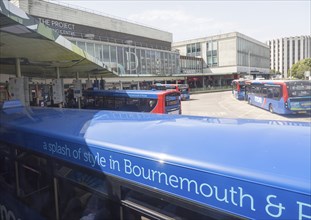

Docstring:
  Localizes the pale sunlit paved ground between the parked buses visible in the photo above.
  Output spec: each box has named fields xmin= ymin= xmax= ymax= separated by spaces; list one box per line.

xmin=182 ymin=91 xmax=311 ymax=122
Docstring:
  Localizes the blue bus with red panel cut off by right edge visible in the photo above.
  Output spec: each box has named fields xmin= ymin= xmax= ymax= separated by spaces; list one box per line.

xmin=247 ymin=80 xmax=311 ymax=114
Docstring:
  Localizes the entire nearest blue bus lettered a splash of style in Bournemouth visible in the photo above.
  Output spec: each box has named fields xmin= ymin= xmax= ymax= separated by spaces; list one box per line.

xmin=0 ymin=100 xmax=311 ymax=220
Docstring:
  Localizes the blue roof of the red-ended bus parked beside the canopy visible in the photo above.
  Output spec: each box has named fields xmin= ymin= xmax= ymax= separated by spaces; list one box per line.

xmin=84 ymin=90 xmax=177 ymax=99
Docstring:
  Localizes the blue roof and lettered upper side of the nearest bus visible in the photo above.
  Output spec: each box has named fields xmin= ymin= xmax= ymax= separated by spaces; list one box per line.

xmin=0 ymin=107 xmax=311 ymax=219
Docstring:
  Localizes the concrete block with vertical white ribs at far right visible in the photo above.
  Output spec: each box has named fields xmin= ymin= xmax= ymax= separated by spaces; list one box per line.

xmin=267 ymin=35 xmax=311 ymax=78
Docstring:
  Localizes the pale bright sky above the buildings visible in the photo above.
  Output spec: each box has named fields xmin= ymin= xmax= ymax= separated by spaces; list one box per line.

xmin=57 ymin=0 xmax=311 ymax=42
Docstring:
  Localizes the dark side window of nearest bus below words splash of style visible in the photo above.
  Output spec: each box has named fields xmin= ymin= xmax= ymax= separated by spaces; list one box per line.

xmin=57 ymin=164 xmax=119 ymax=220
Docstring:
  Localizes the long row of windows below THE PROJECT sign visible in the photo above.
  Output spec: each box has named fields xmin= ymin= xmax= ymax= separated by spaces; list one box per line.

xmin=73 ymin=41 xmax=180 ymax=75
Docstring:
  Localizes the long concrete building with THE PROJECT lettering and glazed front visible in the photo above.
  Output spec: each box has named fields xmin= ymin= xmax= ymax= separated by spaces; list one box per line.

xmin=11 ymin=0 xmax=184 ymax=88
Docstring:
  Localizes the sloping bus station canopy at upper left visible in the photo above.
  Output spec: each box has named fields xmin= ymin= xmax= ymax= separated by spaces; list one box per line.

xmin=0 ymin=0 xmax=114 ymax=78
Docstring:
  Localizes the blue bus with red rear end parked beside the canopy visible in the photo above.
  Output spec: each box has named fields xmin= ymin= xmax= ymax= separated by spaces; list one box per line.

xmin=83 ymin=90 xmax=181 ymax=114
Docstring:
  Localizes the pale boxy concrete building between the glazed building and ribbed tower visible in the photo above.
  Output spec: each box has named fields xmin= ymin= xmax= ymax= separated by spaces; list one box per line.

xmin=172 ymin=32 xmax=270 ymax=85
